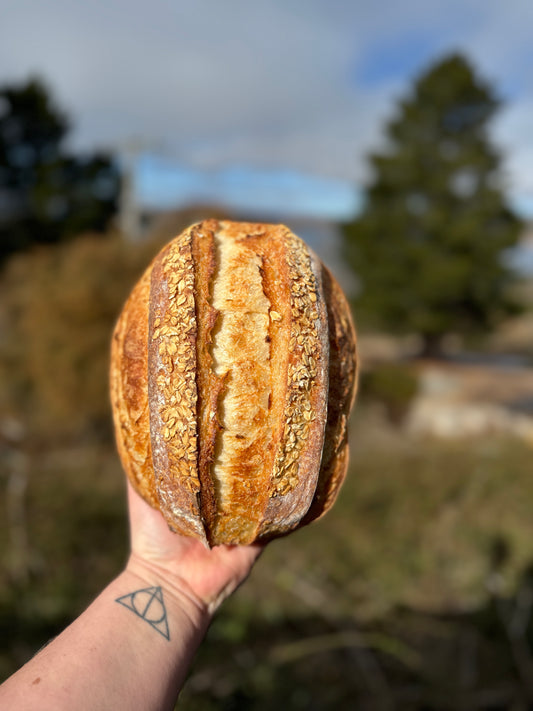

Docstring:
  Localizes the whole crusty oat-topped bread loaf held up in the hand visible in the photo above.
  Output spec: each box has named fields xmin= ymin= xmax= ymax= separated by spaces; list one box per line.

xmin=111 ymin=220 xmax=356 ymax=546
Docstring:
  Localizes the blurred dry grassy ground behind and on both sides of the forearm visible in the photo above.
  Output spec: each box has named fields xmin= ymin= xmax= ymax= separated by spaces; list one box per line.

xmin=0 ymin=408 xmax=533 ymax=711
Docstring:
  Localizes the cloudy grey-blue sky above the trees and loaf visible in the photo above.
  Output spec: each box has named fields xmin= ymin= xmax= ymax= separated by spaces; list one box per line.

xmin=0 ymin=0 xmax=533 ymax=220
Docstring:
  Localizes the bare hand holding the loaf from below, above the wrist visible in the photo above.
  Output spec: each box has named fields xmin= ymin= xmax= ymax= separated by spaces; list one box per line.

xmin=124 ymin=483 xmax=263 ymax=614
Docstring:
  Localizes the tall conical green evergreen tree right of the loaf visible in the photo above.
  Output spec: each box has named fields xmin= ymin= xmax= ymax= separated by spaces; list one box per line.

xmin=344 ymin=54 xmax=521 ymax=352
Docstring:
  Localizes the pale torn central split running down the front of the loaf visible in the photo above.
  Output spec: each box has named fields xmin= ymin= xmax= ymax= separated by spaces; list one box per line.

xmin=207 ymin=227 xmax=273 ymax=540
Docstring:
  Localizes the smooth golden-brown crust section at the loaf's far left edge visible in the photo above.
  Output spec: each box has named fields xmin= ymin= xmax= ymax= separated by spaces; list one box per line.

xmin=111 ymin=268 xmax=158 ymax=506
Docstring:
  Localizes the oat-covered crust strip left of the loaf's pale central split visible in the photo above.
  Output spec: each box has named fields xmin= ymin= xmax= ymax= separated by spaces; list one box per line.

xmin=148 ymin=230 xmax=206 ymax=541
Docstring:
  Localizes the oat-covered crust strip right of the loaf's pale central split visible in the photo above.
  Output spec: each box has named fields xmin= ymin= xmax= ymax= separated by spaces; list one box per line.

xmin=260 ymin=236 xmax=329 ymax=539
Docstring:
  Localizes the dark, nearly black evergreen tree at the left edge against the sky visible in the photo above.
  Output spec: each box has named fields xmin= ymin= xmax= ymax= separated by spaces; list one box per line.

xmin=0 ymin=80 xmax=119 ymax=262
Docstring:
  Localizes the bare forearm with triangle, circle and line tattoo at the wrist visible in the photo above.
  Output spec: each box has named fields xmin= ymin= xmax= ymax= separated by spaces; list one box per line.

xmin=0 ymin=566 xmax=209 ymax=711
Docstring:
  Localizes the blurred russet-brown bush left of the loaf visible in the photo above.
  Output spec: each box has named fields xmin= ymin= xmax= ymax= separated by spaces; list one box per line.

xmin=0 ymin=234 xmax=162 ymax=441
